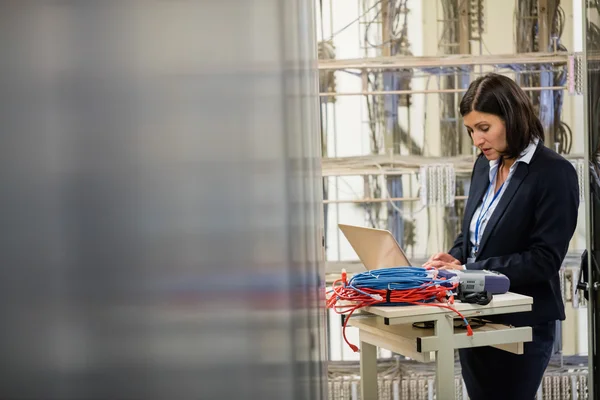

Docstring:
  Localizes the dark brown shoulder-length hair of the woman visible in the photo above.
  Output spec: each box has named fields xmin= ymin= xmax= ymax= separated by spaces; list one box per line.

xmin=460 ymin=73 xmax=544 ymax=158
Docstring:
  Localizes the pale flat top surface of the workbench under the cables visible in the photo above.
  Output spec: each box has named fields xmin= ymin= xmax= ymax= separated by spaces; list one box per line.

xmin=363 ymin=292 xmax=533 ymax=318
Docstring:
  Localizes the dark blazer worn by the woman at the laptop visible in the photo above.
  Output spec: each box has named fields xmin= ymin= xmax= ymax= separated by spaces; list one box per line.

xmin=449 ymin=141 xmax=579 ymax=326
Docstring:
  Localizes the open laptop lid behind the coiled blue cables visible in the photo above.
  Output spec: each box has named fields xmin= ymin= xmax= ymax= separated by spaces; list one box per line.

xmin=338 ymin=224 xmax=411 ymax=271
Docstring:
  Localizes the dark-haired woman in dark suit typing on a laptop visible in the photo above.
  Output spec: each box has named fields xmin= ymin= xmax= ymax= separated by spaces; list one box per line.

xmin=425 ymin=74 xmax=579 ymax=400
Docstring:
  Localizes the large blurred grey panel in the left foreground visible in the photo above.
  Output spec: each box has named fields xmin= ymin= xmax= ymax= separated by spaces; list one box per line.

xmin=0 ymin=0 xmax=326 ymax=400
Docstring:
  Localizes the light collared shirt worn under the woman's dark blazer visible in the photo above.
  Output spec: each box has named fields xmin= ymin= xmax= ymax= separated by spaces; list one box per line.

xmin=469 ymin=138 xmax=539 ymax=257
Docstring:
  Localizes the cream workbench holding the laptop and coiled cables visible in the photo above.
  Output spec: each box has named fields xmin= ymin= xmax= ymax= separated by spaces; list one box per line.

xmin=348 ymin=293 xmax=533 ymax=400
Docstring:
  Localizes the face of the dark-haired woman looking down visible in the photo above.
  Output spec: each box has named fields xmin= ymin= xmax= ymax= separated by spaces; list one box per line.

xmin=463 ymin=111 xmax=508 ymax=161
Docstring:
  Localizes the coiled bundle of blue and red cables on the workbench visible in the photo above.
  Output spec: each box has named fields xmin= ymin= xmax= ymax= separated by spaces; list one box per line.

xmin=327 ymin=267 xmax=473 ymax=352
